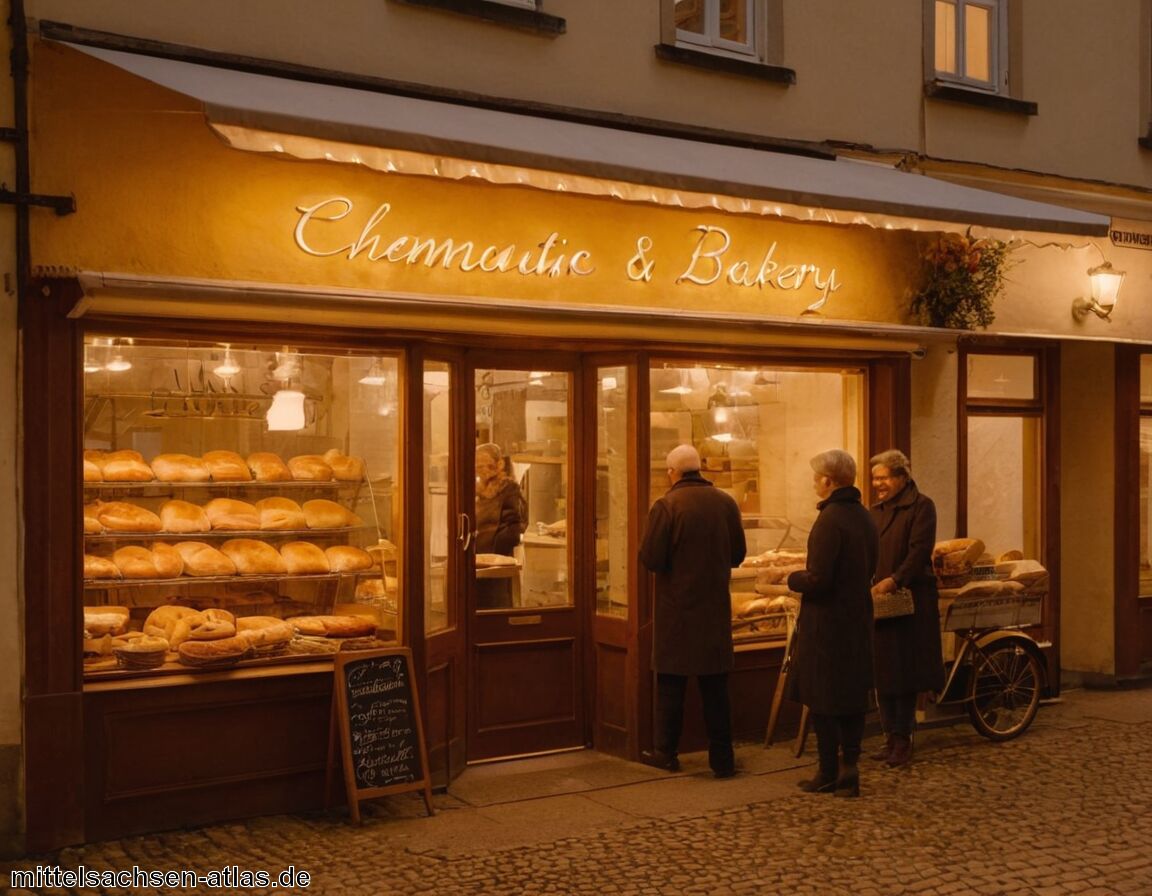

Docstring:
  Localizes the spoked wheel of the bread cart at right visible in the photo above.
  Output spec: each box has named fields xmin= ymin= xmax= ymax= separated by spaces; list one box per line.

xmin=968 ymin=643 xmax=1043 ymax=741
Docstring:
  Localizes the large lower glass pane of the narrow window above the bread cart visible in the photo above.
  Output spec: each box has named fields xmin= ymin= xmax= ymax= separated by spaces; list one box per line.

xmin=968 ymin=416 xmax=1041 ymax=560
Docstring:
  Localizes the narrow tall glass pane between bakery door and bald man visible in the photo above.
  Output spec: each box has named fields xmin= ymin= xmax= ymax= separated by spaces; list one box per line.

xmin=596 ymin=367 xmax=632 ymax=616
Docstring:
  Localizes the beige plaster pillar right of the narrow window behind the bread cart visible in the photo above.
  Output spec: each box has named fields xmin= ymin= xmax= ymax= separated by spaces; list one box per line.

xmin=1060 ymin=342 xmax=1115 ymax=675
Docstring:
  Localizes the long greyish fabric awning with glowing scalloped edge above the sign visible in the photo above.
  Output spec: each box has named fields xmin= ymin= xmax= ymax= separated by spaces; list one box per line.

xmin=69 ymin=44 xmax=1109 ymax=236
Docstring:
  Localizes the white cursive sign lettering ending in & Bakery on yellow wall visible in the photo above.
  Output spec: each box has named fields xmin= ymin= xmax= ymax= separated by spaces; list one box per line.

xmin=293 ymin=196 xmax=842 ymax=304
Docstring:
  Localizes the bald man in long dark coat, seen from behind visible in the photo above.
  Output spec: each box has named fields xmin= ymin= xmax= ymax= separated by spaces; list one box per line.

xmin=641 ymin=445 xmax=746 ymax=777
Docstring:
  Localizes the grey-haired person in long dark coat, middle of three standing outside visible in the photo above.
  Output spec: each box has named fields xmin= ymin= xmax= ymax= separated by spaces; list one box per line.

xmin=786 ymin=449 xmax=879 ymax=797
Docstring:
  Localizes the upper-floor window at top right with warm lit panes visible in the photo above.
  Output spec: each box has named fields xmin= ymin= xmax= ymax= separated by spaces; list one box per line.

xmin=934 ymin=0 xmax=1008 ymax=92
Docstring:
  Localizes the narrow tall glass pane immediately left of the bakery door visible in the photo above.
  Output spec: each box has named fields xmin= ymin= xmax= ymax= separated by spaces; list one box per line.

xmin=424 ymin=362 xmax=456 ymax=632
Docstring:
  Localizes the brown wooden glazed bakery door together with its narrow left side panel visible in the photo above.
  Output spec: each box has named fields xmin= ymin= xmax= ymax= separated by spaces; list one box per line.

xmin=423 ymin=355 xmax=585 ymax=761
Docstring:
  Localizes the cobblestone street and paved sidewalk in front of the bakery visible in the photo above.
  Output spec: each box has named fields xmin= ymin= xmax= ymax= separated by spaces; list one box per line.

xmin=0 ymin=690 xmax=1152 ymax=896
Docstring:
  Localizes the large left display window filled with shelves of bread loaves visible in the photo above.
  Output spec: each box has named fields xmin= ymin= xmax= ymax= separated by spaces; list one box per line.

xmin=79 ymin=335 xmax=401 ymax=681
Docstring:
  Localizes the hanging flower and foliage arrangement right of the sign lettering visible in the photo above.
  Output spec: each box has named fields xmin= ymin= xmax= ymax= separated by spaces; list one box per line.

xmin=912 ymin=230 xmax=1011 ymax=329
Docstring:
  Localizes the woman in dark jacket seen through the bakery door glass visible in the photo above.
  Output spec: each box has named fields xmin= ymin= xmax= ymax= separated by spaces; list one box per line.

xmin=476 ymin=442 xmax=528 ymax=609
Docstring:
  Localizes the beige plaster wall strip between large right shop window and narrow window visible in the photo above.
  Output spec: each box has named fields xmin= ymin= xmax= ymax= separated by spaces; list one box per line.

xmin=907 ymin=344 xmax=958 ymax=541
